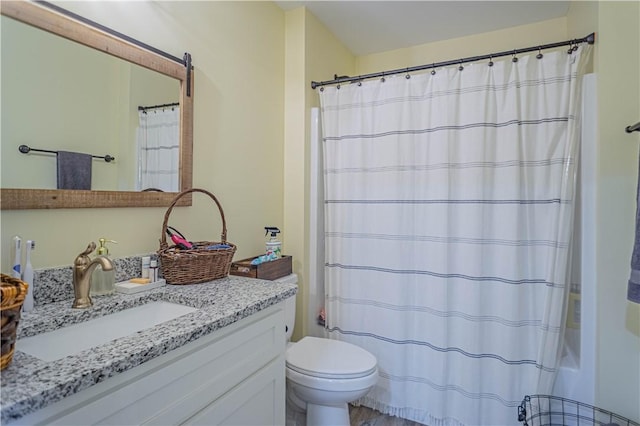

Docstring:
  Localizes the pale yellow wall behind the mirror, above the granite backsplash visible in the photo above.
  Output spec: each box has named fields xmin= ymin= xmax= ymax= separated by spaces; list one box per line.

xmin=0 ymin=1 xmax=285 ymax=272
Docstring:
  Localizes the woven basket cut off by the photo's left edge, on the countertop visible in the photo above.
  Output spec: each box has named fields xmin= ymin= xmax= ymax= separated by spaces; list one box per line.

xmin=0 ymin=274 xmax=29 ymax=370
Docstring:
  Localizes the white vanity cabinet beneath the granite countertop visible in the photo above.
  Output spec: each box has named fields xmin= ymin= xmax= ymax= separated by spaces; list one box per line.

xmin=13 ymin=303 xmax=286 ymax=425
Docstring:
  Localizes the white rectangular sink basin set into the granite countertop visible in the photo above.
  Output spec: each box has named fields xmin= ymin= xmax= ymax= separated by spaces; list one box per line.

xmin=16 ymin=302 xmax=197 ymax=361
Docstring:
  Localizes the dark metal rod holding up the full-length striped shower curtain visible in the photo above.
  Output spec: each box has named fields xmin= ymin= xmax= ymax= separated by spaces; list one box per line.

xmin=311 ymin=33 xmax=596 ymax=89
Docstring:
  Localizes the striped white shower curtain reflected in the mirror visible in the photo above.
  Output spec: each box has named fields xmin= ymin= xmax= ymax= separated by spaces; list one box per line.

xmin=136 ymin=107 xmax=180 ymax=192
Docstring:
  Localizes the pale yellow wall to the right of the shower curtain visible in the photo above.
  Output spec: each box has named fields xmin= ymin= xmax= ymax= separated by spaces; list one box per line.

xmin=569 ymin=1 xmax=640 ymax=421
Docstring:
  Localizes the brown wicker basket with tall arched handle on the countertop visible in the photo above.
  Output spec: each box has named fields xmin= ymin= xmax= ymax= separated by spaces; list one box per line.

xmin=158 ymin=188 xmax=236 ymax=284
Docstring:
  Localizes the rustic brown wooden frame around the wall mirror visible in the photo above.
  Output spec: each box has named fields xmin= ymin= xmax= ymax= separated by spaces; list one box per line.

xmin=0 ymin=1 xmax=194 ymax=210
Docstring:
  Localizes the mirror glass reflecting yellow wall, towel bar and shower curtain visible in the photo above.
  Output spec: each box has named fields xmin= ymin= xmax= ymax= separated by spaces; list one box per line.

xmin=0 ymin=16 xmax=180 ymax=192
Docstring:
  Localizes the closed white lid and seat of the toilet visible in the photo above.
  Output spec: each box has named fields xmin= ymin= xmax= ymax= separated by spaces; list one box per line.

xmin=286 ymin=336 xmax=377 ymax=380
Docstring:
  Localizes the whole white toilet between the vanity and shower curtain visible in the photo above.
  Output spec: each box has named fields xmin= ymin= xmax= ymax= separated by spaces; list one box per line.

xmin=281 ymin=274 xmax=378 ymax=426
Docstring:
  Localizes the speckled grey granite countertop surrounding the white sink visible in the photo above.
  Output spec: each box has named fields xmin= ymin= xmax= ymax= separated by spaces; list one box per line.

xmin=1 ymin=276 xmax=297 ymax=423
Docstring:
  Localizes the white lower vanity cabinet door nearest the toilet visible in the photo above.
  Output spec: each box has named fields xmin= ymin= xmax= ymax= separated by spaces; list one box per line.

xmin=184 ymin=356 xmax=285 ymax=426
